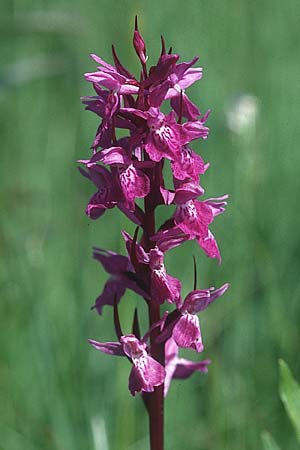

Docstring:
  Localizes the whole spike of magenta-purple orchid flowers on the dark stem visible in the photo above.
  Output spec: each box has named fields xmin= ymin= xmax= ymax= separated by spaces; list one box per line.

xmin=80 ymin=22 xmax=228 ymax=395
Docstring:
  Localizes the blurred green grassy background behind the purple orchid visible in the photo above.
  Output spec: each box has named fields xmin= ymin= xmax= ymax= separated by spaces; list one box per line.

xmin=0 ymin=0 xmax=300 ymax=450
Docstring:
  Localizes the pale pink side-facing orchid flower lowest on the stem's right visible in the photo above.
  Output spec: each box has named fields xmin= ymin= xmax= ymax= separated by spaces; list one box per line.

xmin=164 ymin=337 xmax=211 ymax=397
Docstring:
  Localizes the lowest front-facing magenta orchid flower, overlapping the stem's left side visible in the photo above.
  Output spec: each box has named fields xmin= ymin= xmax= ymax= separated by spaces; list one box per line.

xmin=89 ymin=334 xmax=166 ymax=396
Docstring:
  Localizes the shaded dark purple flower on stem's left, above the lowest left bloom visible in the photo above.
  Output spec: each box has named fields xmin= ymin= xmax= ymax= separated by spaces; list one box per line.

xmin=93 ymin=247 xmax=149 ymax=315
